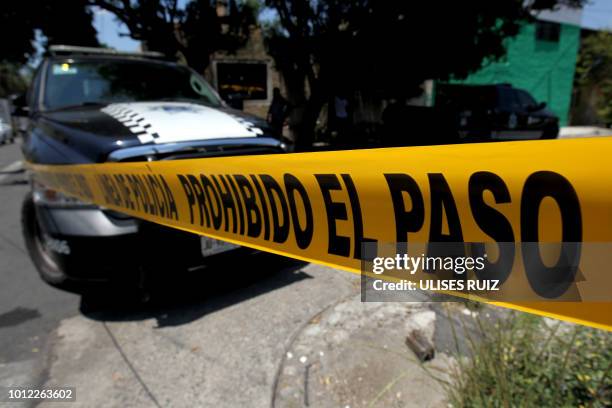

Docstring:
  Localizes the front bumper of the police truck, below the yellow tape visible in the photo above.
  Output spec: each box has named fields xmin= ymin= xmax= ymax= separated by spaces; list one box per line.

xmin=36 ymin=205 xmax=213 ymax=281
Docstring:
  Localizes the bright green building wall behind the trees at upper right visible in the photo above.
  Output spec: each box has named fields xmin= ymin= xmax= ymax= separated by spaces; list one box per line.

xmin=458 ymin=23 xmax=580 ymax=126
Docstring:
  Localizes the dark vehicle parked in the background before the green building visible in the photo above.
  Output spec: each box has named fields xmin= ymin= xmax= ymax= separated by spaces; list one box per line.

xmin=435 ymin=84 xmax=559 ymax=141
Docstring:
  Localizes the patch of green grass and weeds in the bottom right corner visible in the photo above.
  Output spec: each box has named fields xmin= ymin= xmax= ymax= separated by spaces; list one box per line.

xmin=448 ymin=313 xmax=612 ymax=407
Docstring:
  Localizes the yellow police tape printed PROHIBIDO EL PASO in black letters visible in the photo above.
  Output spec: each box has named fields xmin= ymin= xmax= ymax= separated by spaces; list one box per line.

xmin=30 ymin=138 xmax=612 ymax=330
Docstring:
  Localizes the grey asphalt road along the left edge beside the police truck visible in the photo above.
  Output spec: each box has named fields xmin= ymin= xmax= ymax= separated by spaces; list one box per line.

xmin=0 ymin=144 xmax=80 ymax=396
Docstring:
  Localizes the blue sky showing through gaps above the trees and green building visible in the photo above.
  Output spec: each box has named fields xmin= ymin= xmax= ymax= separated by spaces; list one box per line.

xmin=94 ymin=0 xmax=612 ymax=51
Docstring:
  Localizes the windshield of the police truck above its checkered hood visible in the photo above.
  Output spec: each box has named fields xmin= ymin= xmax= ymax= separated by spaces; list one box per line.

xmin=43 ymin=59 xmax=221 ymax=110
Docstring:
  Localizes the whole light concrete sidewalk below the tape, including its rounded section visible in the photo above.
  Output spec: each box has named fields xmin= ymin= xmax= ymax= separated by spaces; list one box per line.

xmin=35 ymin=265 xmax=462 ymax=408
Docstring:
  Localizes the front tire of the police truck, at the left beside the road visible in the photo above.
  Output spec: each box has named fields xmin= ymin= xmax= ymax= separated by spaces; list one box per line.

xmin=21 ymin=193 xmax=75 ymax=291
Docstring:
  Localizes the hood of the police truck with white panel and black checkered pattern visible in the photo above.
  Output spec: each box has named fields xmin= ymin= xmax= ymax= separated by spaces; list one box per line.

xmin=39 ymin=102 xmax=270 ymax=161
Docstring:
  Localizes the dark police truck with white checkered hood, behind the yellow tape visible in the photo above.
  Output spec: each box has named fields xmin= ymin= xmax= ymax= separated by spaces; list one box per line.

xmin=14 ymin=46 xmax=284 ymax=290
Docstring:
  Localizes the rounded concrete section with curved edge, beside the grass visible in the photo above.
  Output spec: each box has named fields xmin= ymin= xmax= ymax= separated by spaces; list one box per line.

xmin=273 ymin=295 xmax=453 ymax=408
